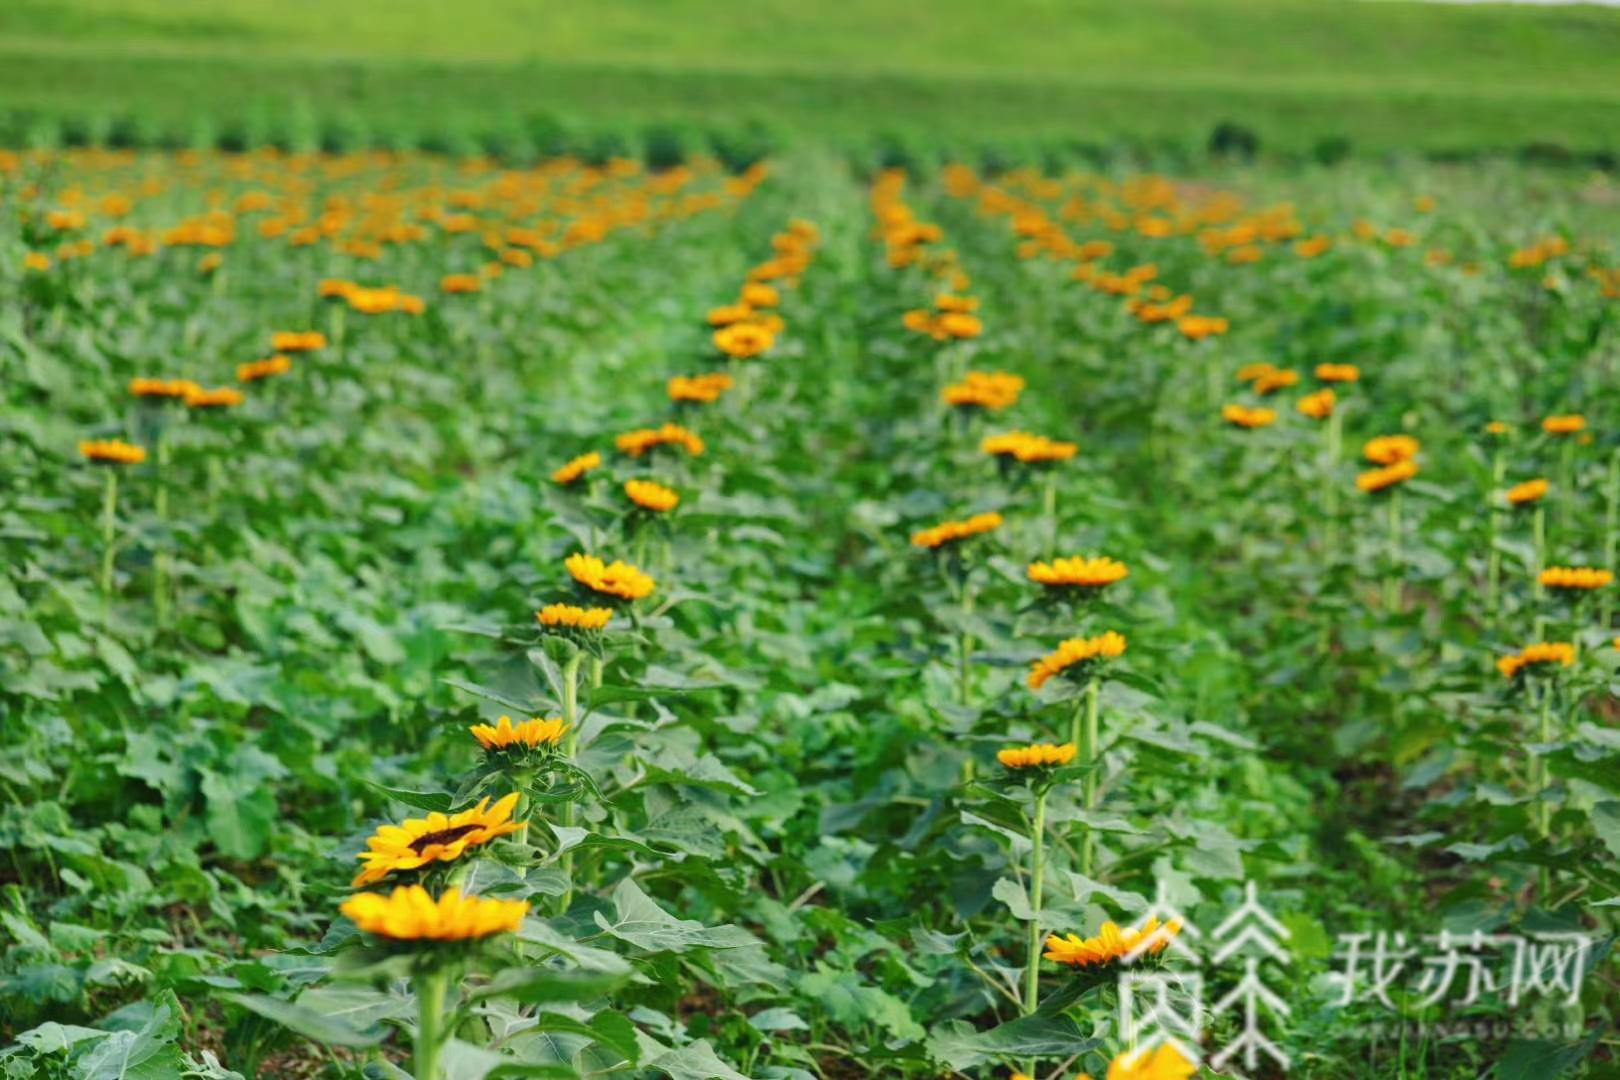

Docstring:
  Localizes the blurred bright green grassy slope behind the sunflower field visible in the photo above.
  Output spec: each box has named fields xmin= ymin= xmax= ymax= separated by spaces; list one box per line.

xmin=0 ymin=0 xmax=1620 ymax=152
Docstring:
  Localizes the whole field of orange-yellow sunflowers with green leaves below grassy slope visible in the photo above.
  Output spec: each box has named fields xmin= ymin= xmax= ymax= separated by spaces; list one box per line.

xmin=0 ymin=137 xmax=1620 ymax=1080
